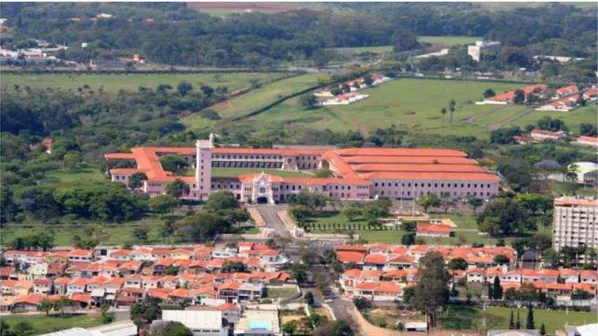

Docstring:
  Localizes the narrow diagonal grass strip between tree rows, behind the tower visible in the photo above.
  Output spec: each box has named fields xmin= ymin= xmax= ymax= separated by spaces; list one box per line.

xmin=183 ymin=75 xmax=321 ymax=129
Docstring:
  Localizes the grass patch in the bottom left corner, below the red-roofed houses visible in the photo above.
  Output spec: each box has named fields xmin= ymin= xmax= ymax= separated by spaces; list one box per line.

xmin=2 ymin=315 xmax=102 ymax=335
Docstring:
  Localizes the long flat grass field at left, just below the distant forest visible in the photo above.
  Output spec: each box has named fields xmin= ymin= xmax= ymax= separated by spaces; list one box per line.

xmin=2 ymin=73 xmax=283 ymax=93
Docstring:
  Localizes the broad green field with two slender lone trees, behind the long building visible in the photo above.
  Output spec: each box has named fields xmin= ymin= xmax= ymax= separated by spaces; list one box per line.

xmin=248 ymin=78 xmax=523 ymax=137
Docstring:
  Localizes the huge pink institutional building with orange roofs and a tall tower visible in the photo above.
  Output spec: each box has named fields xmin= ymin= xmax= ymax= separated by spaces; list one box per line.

xmin=105 ymin=136 xmax=499 ymax=203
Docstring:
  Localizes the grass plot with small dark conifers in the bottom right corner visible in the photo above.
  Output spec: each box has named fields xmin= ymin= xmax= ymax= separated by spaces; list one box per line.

xmin=441 ymin=306 xmax=598 ymax=334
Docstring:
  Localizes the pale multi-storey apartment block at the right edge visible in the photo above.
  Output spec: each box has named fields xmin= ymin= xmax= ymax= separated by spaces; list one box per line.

xmin=552 ymin=197 xmax=598 ymax=251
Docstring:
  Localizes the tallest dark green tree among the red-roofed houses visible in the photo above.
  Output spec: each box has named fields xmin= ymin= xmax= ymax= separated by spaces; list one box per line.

xmin=409 ymin=252 xmax=451 ymax=326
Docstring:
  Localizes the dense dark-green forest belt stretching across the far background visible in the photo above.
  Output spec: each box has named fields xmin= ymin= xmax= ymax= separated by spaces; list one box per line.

xmin=2 ymin=3 xmax=598 ymax=67
